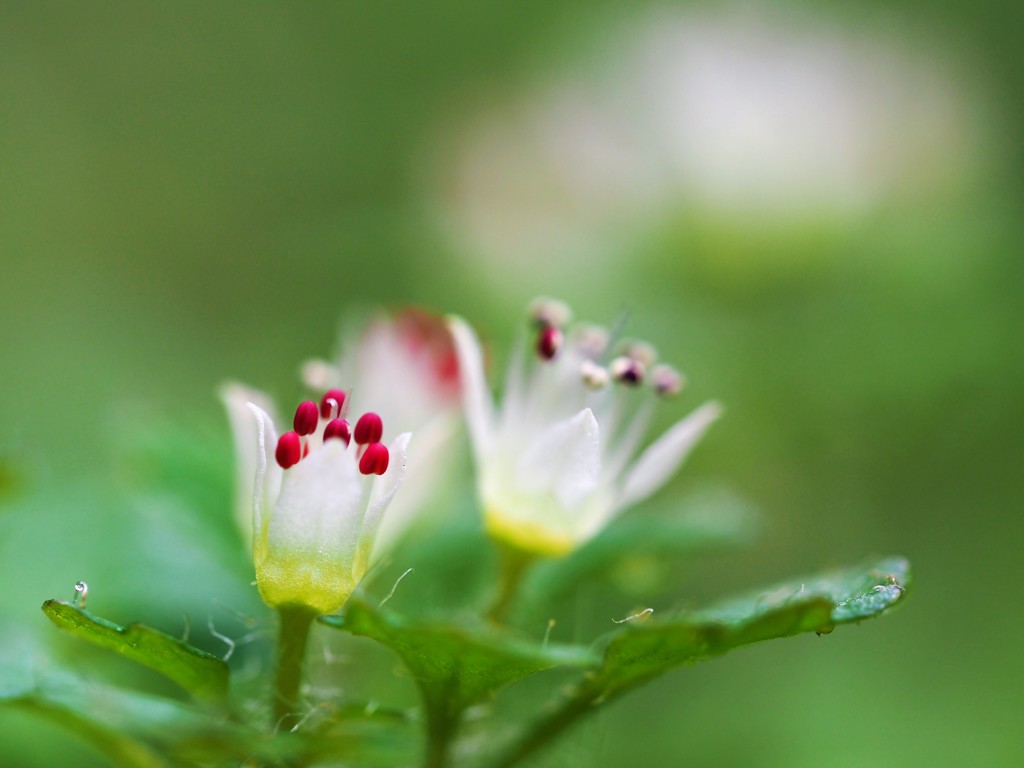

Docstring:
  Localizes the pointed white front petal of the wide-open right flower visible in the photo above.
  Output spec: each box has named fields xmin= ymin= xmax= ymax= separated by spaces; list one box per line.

xmin=515 ymin=408 xmax=601 ymax=507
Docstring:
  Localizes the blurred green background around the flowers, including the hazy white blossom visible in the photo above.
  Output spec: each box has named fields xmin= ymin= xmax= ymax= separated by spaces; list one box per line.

xmin=0 ymin=0 xmax=1024 ymax=766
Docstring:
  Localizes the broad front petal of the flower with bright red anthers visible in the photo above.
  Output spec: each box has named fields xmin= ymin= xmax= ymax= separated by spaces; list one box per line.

xmin=268 ymin=440 xmax=365 ymax=573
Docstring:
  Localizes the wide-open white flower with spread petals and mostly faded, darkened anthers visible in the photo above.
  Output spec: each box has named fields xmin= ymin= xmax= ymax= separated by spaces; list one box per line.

xmin=450 ymin=300 xmax=721 ymax=556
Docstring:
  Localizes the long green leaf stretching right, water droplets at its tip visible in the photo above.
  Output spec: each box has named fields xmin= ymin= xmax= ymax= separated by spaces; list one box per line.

xmin=590 ymin=558 xmax=909 ymax=696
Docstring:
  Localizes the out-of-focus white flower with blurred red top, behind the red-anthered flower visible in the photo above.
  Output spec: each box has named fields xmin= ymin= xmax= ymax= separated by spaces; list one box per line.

xmin=302 ymin=308 xmax=461 ymax=555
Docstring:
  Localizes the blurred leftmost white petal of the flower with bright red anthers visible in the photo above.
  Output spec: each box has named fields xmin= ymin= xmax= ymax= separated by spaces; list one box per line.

xmin=218 ymin=382 xmax=276 ymax=543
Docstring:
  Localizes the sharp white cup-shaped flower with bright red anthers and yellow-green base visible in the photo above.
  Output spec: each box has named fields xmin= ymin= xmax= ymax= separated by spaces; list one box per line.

xmin=222 ymin=384 xmax=410 ymax=613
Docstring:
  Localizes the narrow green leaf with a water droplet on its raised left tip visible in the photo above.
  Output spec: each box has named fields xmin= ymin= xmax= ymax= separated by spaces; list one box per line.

xmin=43 ymin=600 xmax=228 ymax=701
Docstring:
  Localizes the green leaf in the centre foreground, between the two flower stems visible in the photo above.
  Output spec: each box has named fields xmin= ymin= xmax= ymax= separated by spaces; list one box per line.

xmin=319 ymin=598 xmax=598 ymax=714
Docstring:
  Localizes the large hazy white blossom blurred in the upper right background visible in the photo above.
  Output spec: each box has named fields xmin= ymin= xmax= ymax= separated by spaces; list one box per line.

xmin=441 ymin=9 xmax=977 ymax=285
